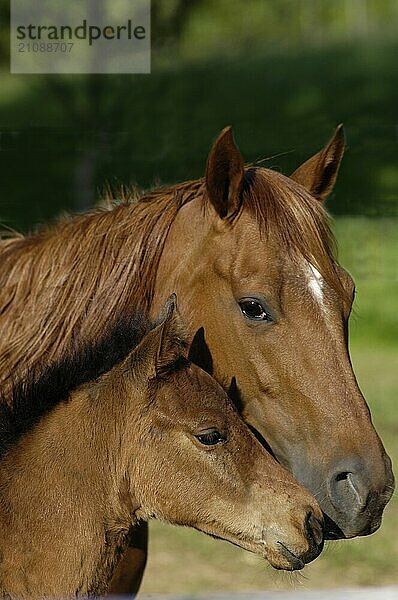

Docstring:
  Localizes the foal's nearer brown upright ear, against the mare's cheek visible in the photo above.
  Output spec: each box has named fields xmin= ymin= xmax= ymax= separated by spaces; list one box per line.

xmin=155 ymin=294 xmax=188 ymax=375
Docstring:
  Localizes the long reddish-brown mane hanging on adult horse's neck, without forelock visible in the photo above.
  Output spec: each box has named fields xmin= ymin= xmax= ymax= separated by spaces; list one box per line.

xmin=0 ymin=182 xmax=198 ymax=392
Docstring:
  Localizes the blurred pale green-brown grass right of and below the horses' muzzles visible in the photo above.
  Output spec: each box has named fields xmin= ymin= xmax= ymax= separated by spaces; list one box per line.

xmin=138 ymin=218 xmax=398 ymax=594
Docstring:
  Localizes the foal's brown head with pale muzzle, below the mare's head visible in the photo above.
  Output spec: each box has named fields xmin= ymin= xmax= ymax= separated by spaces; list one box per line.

xmin=107 ymin=302 xmax=323 ymax=570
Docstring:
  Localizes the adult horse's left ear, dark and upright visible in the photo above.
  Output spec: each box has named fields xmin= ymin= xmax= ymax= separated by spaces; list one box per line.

xmin=206 ymin=127 xmax=244 ymax=219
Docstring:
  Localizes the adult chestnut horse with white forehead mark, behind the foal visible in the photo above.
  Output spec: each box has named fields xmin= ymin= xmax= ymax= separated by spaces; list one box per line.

xmin=0 ymin=127 xmax=394 ymax=593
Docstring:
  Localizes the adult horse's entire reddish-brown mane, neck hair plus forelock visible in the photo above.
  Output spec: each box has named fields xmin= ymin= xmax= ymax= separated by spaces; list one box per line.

xmin=0 ymin=167 xmax=344 ymax=402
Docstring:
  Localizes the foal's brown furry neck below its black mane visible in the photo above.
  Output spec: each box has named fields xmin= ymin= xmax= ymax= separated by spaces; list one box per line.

xmin=0 ymin=384 xmax=137 ymax=598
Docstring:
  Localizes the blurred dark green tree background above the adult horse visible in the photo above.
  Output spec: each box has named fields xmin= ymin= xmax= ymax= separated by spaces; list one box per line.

xmin=0 ymin=0 xmax=398 ymax=228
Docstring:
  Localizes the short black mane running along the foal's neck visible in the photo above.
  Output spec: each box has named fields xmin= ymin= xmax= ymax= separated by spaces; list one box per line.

xmin=0 ymin=313 xmax=154 ymax=458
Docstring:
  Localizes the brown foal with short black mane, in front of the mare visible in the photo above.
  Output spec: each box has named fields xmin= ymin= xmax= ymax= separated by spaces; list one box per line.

xmin=0 ymin=300 xmax=323 ymax=598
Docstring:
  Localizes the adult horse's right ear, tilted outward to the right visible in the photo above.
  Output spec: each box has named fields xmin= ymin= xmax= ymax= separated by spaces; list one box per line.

xmin=290 ymin=125 xmax=345 ymax=201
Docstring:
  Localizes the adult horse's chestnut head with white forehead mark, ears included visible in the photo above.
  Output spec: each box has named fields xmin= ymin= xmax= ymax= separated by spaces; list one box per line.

xmin=153 ymin=127 xmax=394 ymax=537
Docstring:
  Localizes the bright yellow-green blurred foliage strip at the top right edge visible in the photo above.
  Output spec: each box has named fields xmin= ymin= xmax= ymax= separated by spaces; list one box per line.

xmin=182 ymin=0 xmax=398 ymax=56
